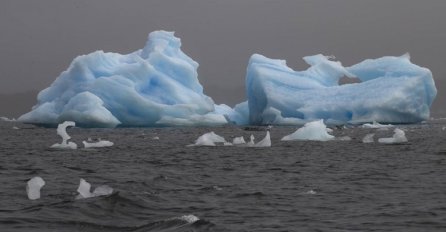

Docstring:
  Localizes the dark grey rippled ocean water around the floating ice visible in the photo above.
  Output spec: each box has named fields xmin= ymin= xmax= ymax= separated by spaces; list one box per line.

xmin=0 ymin=119 xmax=446 ymax=232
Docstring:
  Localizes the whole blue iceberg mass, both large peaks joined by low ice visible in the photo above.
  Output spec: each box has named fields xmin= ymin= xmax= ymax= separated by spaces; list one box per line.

xmin=18 ymin=31 xmax=436 ymax=127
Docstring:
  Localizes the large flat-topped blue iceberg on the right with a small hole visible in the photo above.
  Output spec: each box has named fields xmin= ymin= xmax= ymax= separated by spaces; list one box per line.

xmin=246 ymin=54 xmax=437 ymax=125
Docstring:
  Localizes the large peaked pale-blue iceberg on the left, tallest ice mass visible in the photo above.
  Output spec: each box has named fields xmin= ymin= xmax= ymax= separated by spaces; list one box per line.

xmin=19 ymin=31 xmax=227 ymax=127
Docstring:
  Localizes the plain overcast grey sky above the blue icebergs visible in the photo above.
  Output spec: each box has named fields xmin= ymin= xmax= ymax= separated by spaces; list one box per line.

xmin=0 ymin=0 xmax=446 ymax=115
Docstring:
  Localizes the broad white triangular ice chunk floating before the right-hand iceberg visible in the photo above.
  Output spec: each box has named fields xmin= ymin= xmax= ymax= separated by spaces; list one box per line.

xmin=281 ymin=119 xmax=335 ymax=141
